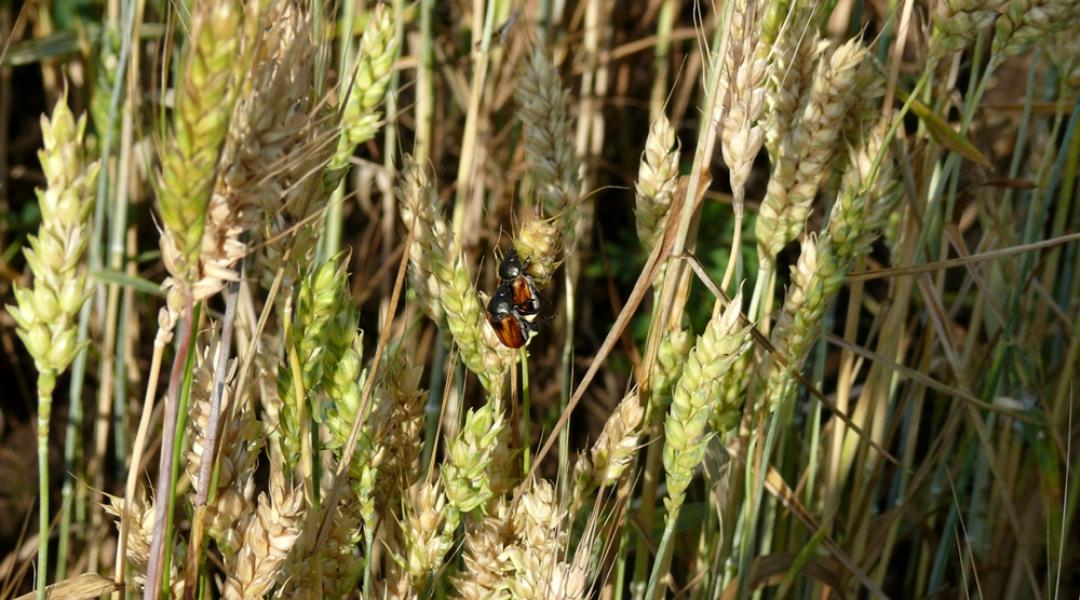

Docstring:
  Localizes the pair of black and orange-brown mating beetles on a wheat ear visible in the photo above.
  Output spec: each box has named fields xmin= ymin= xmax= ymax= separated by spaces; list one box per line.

xmin=487 ymin=248 xmax=540 ymax=347
